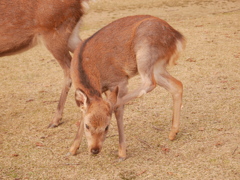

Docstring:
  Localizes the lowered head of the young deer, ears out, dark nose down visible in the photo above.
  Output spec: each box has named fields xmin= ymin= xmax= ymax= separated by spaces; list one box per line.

xmin=75 ymin=89 xmax=118 ymax=154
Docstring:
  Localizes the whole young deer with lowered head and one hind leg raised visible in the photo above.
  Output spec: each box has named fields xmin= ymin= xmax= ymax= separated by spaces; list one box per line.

xmin=70 ymin=15 xmax=185 ymax=159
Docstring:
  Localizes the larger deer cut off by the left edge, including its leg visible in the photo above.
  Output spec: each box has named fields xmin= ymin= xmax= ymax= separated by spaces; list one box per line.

xmin=0 ymin=0 xmax=87 ymax=127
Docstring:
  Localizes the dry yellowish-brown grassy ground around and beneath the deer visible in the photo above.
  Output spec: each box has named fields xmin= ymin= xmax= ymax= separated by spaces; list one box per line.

xmin=0 ymin=0 xmax=240 ymax=180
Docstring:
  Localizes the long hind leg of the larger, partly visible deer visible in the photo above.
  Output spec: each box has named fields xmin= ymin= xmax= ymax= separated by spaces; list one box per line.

xmin=43 ymin=32 xmax=72 ymax=128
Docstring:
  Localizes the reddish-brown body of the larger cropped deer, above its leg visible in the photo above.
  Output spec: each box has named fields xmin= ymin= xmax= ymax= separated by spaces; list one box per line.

xmin=0 ymin=0 xmax=83 ymax=56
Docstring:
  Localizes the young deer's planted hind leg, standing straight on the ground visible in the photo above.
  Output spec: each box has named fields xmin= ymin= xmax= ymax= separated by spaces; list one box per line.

xmin=154 ymin=62 xmax=183 ymax=140
